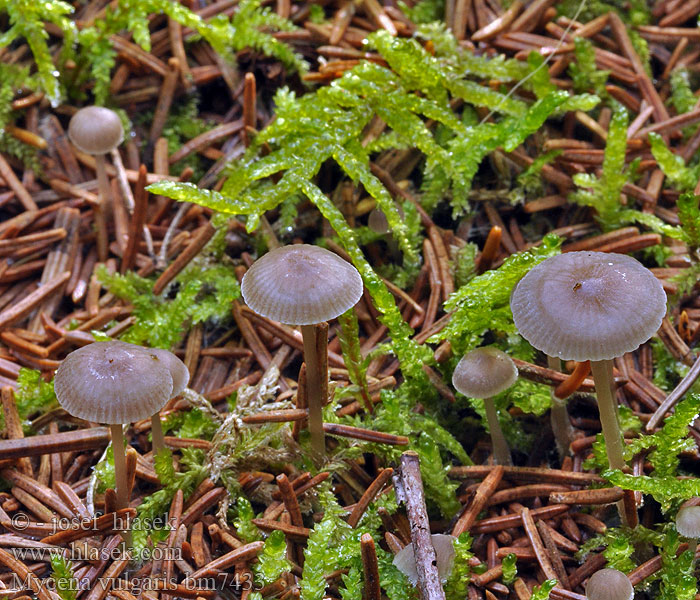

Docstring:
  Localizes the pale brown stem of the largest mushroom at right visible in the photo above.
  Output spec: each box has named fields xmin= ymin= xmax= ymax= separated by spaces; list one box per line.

xmin=591 ymin=360 xmax=636 ymax=526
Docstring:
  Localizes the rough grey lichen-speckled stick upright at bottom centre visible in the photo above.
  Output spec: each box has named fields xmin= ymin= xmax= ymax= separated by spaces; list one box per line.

xmin=394 ymin=451 xmax=445 ymax=600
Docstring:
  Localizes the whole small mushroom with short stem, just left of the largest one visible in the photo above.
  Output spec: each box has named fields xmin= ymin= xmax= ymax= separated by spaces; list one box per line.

xmin=452 ymin=347 xmax=518 ymax=465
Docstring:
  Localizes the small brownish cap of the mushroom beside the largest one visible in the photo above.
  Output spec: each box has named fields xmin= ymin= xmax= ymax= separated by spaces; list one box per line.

xmin=452 ymin=346 xmax=518 ymax=398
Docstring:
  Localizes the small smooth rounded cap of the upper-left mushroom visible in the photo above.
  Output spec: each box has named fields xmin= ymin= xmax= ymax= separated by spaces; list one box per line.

xmin=68 ymin=106 xmax=124 ymax=155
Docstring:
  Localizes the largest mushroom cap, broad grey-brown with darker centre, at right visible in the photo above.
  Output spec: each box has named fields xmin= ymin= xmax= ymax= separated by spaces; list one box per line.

xmin=510 ymin=252 xmax=666 ymax=362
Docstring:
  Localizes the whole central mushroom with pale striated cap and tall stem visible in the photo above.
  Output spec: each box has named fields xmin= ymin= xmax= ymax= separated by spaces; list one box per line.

xmin=241 ymin=244 xmax=362 ymax=460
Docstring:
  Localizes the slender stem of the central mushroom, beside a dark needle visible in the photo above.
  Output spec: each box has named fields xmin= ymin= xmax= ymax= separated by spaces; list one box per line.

xmin=301 ymin=323 xmax=328 ymax=462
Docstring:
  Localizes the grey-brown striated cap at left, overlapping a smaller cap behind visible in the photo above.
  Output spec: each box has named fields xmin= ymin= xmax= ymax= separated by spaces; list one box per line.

xmin=54 ymin=340 xmax=173 ymax=425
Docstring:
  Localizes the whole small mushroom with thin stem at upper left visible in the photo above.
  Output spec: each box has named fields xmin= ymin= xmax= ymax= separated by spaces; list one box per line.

xmin=68 ymin=106 xmax=124 ymax=262
